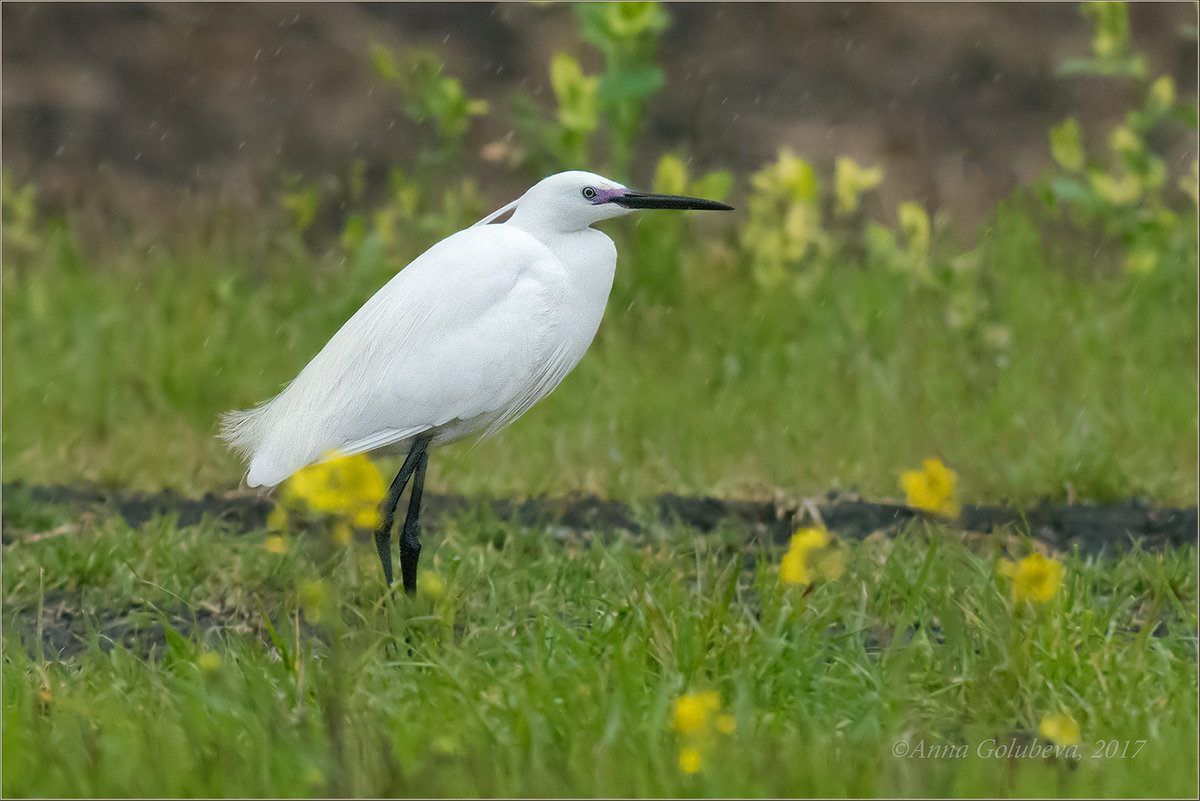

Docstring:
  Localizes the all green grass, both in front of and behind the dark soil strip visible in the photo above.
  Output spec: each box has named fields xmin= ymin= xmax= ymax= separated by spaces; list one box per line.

xmin=2 ymin=169 xmax=1200 ymax=796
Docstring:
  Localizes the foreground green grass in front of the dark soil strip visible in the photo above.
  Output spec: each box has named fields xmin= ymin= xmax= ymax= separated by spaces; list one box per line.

xmin=2 ymin=499 xmax=1198 ymax=797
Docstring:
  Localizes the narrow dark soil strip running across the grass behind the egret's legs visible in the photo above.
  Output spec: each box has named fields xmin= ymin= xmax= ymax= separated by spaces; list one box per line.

xmin=4 ymin=483 xmax=1198 ymax=554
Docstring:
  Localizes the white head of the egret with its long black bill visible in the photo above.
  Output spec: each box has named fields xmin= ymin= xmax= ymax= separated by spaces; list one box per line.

xmin=511 ymin=170 xmax=732 ymax=234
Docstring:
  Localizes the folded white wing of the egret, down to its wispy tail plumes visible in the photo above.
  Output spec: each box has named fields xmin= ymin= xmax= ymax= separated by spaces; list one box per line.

xmin=222 ymin=225 xmax=576 ymax=486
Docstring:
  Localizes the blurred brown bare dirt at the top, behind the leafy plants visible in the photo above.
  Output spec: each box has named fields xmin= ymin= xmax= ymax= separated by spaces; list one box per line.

xmin=0 ymin=2 xmax=1196 ymax=244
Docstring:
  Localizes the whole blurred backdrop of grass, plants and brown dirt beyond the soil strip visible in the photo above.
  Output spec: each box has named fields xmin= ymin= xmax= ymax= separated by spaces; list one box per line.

xmin=2 ymin=2 xmax=1198 ymax=502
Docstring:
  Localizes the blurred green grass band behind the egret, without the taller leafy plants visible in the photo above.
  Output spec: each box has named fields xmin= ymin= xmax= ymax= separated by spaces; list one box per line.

xmin=4 ymin=196 xmax=1198 ymax=504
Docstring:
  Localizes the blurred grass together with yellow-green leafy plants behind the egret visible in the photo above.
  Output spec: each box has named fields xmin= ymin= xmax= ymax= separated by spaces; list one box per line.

xmin=4 ymin=6 xmax=1198 ymax=500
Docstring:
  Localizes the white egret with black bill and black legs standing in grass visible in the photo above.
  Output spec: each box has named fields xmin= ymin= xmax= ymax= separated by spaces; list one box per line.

xmin=221 ymin=171 xmax=731 ymax=592
